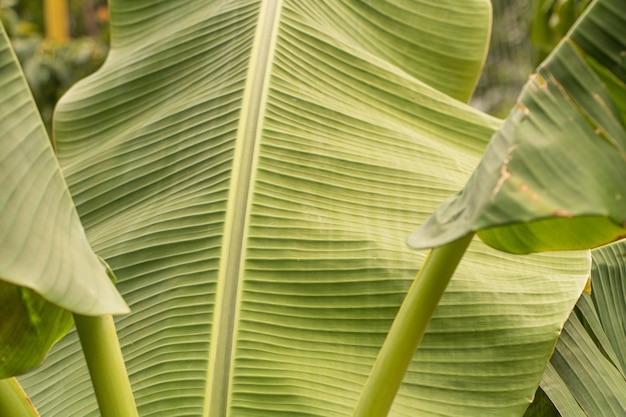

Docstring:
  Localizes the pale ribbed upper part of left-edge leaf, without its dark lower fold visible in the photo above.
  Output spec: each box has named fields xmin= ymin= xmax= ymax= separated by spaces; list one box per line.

xmin=0 ymin=23 xmax=128 ymax=315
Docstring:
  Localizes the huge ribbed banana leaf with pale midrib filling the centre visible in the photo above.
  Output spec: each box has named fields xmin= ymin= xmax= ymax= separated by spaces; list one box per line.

xmin=21 ymin=0 xmax=590 ymax=417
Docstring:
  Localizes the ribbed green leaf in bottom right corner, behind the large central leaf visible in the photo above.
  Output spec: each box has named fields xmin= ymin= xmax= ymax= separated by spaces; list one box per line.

xmin=528 ymin=241 xmax=626 ymax=417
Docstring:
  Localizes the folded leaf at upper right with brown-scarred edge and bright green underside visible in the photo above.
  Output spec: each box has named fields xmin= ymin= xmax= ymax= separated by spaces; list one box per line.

xmin=409 ymin=0 xmax=626 ymax=253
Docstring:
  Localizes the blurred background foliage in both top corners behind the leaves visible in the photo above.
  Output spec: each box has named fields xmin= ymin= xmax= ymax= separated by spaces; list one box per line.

xmin=0 ymin=0 xmax=591 ymax=131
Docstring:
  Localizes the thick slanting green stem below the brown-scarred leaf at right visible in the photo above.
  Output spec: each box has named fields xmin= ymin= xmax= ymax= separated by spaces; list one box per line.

xmin=353 ymin=233 xmax=474 ymax=417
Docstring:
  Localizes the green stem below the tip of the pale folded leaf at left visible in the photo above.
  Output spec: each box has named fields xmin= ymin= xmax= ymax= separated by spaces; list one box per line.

xmin=74 ymin=314 xmax=139 ymax=417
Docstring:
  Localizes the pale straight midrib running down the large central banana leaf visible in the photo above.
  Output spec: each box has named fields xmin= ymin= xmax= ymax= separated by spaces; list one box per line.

xmin=203 ymin=0 xmax=282 ymax=417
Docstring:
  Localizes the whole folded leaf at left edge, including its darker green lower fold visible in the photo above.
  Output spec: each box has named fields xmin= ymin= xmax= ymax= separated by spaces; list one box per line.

xmin=0 ymin=25 xmax=128 ymax=378
